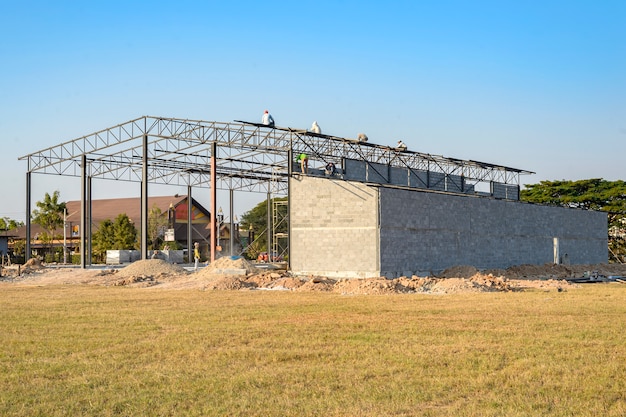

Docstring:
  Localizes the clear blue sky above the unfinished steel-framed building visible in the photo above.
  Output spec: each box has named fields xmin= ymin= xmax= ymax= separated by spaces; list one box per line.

xmin=0 ymin=0 xmax=626 ymax=220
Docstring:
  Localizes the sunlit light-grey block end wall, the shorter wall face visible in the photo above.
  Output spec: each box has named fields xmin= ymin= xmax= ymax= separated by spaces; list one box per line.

xmin=289 ymin=176 xmax=380 ymax=278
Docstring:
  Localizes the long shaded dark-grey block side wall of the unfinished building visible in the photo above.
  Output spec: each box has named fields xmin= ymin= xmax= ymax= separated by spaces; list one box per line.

xmin=380 ymin=188 xmax=608 ymax=277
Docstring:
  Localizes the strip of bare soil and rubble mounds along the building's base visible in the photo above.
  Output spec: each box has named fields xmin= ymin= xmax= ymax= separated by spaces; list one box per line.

xmin=0 ymin=257 xmax=626 ymax=295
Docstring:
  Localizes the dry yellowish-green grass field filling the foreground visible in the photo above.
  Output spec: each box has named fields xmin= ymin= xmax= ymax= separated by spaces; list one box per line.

xmin=0 ymin=284 xmax=626 ymax=416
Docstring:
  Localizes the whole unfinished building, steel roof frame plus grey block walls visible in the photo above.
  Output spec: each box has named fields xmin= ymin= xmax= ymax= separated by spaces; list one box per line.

xmin=20 ymin=116 xmax=608 ymax=277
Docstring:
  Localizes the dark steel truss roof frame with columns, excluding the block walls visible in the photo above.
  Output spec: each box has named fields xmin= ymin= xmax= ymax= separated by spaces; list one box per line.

xmin=19 ymin=116 xmax=533 ymax=266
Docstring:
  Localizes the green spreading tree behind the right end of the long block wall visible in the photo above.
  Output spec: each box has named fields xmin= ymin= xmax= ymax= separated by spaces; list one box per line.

xmin=520 ymin=178 xmax=626 ymax=262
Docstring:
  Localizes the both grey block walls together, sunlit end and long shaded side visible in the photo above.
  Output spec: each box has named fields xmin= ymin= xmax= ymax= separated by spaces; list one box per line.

xmin=290 ymin=177 xmax=608 ymax=277
